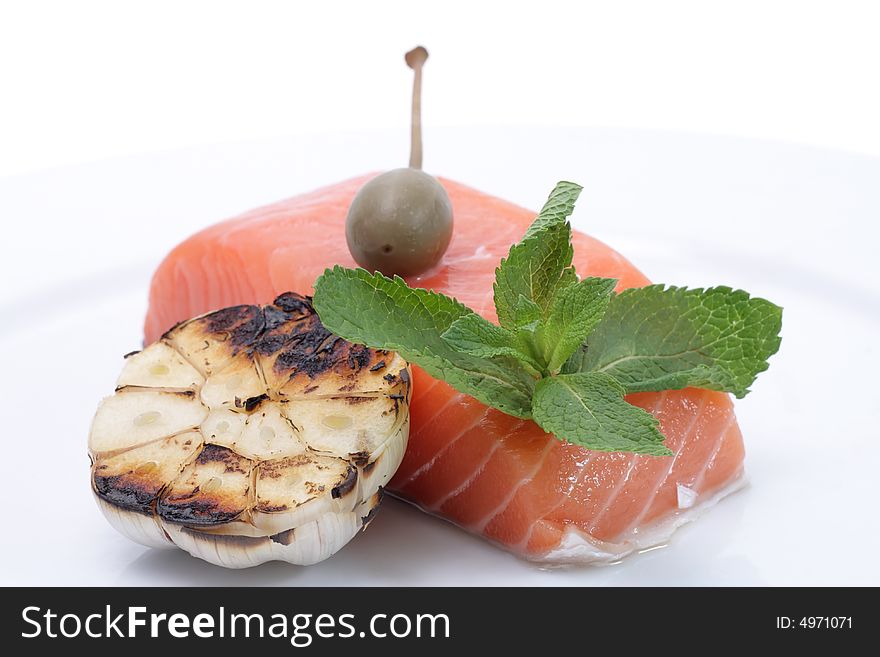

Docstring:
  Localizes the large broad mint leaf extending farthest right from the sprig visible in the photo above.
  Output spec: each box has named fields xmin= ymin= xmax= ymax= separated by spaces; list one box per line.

xmin=564 ymin=285 xmax=782 ymax=397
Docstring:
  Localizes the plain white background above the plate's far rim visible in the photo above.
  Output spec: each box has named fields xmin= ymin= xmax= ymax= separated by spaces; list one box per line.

xmin=0 ymin=0 xmax=880 ymax=176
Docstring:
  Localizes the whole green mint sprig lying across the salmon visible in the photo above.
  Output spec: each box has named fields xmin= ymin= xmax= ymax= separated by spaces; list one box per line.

xmin=314 ymin=182 xmax=782 ymax=456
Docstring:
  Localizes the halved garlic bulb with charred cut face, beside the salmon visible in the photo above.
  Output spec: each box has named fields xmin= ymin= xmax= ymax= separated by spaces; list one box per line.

xmin=89 ymin=293 xmax=410 ymax=568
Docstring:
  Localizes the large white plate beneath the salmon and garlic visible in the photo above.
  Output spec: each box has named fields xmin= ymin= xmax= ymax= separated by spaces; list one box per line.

xmin=0 ymin=128 xmax=880 ymax=585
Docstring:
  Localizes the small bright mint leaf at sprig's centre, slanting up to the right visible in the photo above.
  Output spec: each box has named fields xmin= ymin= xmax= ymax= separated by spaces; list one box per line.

xmin=540 ymin=277 xmax=617 ymax=373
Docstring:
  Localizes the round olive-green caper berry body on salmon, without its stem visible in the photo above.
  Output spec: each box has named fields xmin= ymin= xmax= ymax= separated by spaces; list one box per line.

xmin=345 ymin=168 xmax=452 ymax=276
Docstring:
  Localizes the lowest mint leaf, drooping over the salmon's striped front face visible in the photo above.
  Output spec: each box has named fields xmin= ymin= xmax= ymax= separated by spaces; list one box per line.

xmin=532 ymin=372 xmax=672 ymax=456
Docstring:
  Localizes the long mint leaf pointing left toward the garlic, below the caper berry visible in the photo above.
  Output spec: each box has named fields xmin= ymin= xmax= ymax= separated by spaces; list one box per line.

xmin=313 ymin=266 xmax=535 ymax=418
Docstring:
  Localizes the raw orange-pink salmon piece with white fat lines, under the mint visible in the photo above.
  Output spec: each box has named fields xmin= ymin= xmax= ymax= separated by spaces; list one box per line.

xmin=145 ymin=176 xmax=743 ymax=563
